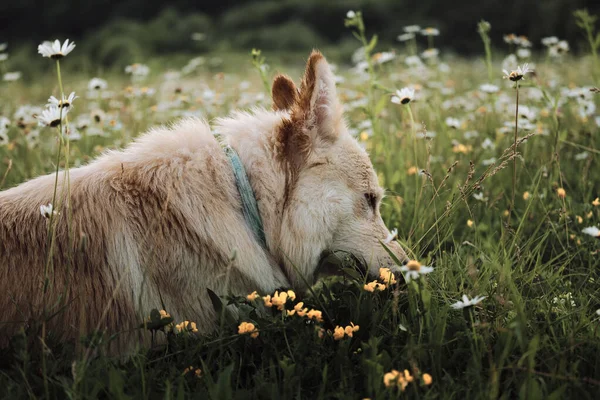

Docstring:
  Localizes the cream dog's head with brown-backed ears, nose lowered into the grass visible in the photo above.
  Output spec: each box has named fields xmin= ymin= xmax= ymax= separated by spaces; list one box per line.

xmin=273 ymin=52 xmax=406 ymax=285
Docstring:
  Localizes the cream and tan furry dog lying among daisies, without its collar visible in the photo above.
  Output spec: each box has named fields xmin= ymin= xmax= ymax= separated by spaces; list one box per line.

xmin=0 ymin=52 xmax=405 ymax=345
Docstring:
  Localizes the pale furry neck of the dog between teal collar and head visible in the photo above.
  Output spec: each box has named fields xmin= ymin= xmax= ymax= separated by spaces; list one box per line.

xmin=215 ymin=110 xmax=287 ymax=265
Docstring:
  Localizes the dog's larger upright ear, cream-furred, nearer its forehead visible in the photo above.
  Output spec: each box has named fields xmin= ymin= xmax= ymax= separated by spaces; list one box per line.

xmin=293 ymin=50 xmax=342 ymax=142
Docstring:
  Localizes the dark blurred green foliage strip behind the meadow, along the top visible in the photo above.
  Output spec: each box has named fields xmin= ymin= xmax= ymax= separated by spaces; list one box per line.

xmin=0 ymin=0 xmax=600 ymax=72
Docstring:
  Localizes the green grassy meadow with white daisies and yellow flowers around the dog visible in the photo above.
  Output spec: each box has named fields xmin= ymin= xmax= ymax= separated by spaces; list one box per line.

xmin=0 ymin=12 xmax=600 ymax=399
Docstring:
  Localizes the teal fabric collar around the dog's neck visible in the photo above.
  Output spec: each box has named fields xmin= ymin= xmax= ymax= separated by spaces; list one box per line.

xmin=222 ymin=144 xmax=267 ymax=249
